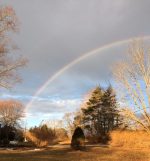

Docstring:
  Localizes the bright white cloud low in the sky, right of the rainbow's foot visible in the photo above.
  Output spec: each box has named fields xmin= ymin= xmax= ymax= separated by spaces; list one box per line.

xmin=24 ymin=98 xmax=81 ymax=127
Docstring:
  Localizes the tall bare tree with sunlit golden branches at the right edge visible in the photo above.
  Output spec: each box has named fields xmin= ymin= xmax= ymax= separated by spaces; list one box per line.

xmin=113 ymin=41 xmax=150 ymax=132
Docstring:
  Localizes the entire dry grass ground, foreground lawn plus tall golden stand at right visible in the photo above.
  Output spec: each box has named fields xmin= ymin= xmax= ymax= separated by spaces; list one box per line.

xmin=0 ymin=131 xmax=150 ymax=161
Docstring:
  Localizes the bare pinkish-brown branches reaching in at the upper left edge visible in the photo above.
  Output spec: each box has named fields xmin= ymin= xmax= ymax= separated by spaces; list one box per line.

xmin=0 ymin=7 xmax=27 ymax=88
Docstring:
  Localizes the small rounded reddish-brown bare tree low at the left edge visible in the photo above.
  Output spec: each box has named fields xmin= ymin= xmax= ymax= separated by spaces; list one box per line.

xmin=0 ymin=100 xmax=24 ymax=127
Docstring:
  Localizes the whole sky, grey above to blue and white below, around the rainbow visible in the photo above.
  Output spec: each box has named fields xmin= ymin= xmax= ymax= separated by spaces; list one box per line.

xmin=0 ymin=0 xmax=150 ymax=126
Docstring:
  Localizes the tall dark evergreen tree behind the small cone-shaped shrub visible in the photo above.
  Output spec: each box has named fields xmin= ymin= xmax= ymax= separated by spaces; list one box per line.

xmin=82 ymin=86 xmax=119 ymax=140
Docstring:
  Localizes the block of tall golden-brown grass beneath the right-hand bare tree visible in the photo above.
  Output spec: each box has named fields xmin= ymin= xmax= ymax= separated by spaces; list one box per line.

xmin=110 ymin=131 xmax=150 ymax=148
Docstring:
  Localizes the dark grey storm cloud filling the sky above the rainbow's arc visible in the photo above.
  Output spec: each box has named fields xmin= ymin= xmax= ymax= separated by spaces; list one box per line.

xmin=2 ymin=0 xmax=150 ymax=88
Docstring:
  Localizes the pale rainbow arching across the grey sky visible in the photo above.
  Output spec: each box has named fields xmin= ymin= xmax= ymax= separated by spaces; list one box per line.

xmin=26 ymin=35 xmax=150 ymax=111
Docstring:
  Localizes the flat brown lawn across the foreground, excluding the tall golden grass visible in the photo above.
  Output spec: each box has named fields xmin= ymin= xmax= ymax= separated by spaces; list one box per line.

xmin=0 ymin=146 xmax=150 ymax=161
